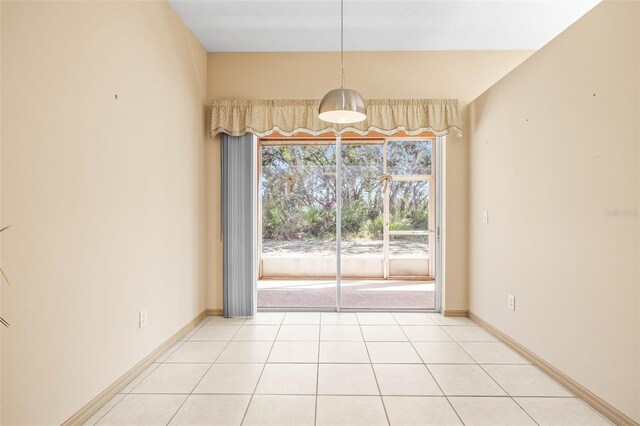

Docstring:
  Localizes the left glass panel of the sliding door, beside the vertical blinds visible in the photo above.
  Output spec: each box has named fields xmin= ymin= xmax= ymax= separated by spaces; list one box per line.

xmin=258 ymin=142 xmax=337 ymax=310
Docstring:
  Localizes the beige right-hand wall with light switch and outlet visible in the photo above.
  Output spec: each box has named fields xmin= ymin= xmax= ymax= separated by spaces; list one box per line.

xmin=467 ymin=1 xmax=640 ymax=421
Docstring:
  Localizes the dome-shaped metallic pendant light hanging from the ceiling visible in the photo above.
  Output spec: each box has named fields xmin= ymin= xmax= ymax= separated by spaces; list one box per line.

xmin=318 ymin=0 xmax=367 ymax=124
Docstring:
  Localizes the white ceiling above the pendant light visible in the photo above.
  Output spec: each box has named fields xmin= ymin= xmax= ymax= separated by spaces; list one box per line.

xmin=170 ymin=0 xmax=600 ymax=52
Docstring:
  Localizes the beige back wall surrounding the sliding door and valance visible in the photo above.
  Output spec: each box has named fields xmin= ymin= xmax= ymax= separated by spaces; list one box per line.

xmin=207 ymin=51 xmax=531 ymax=309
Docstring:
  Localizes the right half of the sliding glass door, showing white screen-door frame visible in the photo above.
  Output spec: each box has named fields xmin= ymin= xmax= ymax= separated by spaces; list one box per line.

xmin=340 ymin=138 xmax=435 ymax=310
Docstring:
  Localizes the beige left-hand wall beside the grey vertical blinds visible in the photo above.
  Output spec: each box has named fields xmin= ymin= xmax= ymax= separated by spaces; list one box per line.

xmin=0 ymin=1 xmax=206 ymax=425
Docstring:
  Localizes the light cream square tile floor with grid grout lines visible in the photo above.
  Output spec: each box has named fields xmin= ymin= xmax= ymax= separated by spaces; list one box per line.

xmin=87 ymin=312 xmax=610 ymax=426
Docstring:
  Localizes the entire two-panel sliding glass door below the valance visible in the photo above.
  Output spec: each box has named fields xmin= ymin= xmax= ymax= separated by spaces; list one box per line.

xmin=258 ymin=138 xmax=436 ymax=310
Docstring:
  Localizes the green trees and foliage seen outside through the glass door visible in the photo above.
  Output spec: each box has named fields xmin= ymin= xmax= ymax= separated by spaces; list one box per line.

xmin=260 ymin=143 xmax=431 ymax=240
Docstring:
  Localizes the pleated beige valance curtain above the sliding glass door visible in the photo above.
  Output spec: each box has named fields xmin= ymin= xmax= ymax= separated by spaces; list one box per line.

xmin=210 ymin=99 xmax=462 ymax=137
